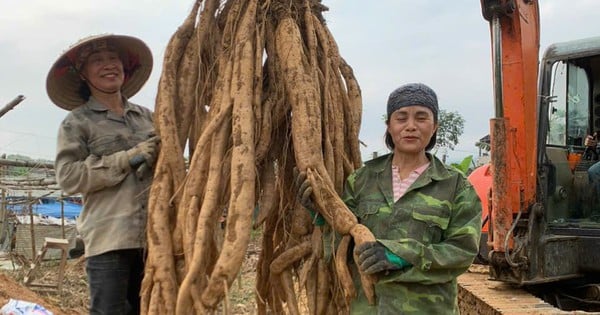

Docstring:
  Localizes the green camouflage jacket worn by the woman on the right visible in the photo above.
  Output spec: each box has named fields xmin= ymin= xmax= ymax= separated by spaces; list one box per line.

xmin=343 ymin=154 xmax=481 ymax=314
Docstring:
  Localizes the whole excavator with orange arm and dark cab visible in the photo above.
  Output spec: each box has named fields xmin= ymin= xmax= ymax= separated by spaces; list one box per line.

xmin=469 ymin=0 xmax=600 ymax=311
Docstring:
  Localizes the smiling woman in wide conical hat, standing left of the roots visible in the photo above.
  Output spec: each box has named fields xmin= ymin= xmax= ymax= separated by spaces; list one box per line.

xmin=46 ymin=34 xmax=159 ymax=314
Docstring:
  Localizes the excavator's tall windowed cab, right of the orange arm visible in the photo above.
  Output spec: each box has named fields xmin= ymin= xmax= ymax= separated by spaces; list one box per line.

xmin=537 ymin=37 xmax=600 ymax=288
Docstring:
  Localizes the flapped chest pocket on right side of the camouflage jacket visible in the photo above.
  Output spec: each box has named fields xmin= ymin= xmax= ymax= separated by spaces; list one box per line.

xmin=408 ymin=207 xmax=450 ymax=245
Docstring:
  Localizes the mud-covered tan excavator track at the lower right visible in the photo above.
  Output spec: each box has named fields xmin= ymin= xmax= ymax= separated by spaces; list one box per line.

xmin=458 ymin=265 xmax=600 ymax=315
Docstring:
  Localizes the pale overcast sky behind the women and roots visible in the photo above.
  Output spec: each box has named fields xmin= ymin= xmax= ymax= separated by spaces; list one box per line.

xmin=0 ymin=0 xmax=600 ymax=160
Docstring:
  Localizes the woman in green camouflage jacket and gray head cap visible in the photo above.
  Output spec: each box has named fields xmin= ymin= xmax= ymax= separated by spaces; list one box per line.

xmin=295 ymin=83 xmax=481 ymax=314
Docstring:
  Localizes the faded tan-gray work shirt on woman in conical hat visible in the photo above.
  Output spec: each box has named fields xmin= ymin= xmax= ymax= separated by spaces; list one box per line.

xmin=55 ymin=97 xmax=154 ymax=257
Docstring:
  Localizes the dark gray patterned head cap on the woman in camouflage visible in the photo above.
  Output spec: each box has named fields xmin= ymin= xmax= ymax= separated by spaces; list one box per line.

xmin=387 ymin=83 xmax=438 ymax=122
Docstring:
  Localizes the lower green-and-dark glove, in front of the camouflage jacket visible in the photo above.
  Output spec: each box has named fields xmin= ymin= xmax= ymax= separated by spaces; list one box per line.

xmin=354 ymin=242 xmax=412 ymax=275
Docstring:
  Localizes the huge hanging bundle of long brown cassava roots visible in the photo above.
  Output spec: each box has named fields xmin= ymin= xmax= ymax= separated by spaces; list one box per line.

xmin=141 ymin=0 xmax=374 ymax=314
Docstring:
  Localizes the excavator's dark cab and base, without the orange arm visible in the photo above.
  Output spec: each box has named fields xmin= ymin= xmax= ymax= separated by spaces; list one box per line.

xmin=488 ymin=37 xmax=600 ymax=311
